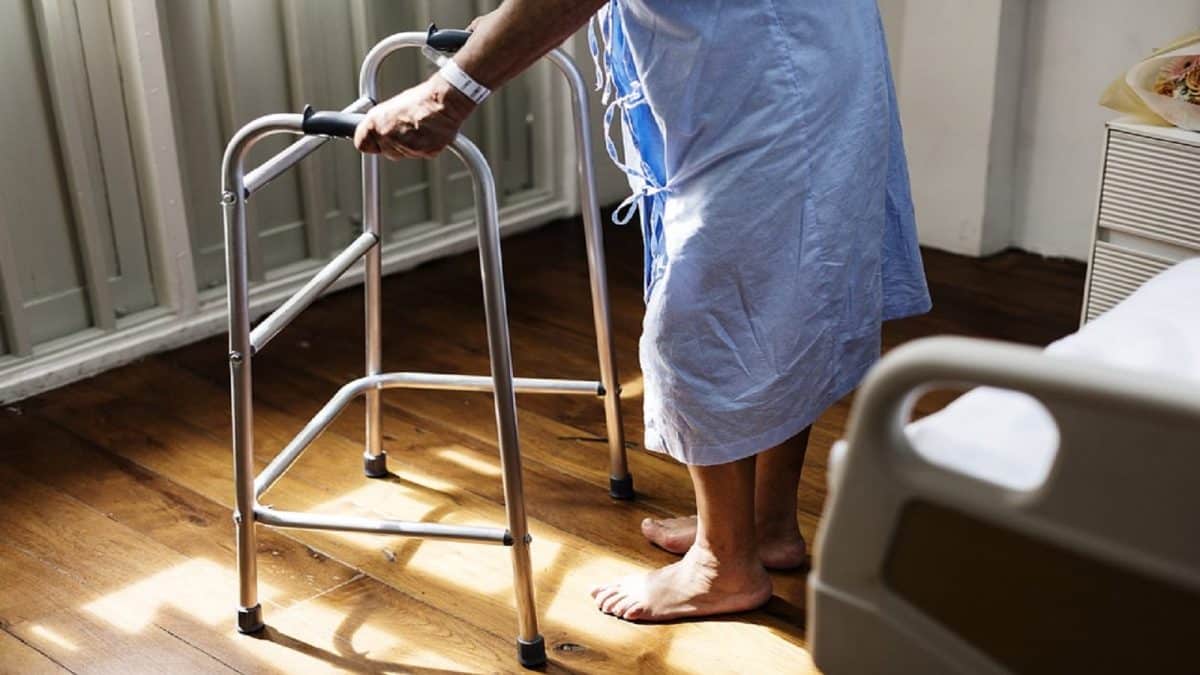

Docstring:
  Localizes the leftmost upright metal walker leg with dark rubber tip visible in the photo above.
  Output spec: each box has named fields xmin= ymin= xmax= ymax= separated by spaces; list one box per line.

xmin=221 ymin=189 xmax=263 ymax=633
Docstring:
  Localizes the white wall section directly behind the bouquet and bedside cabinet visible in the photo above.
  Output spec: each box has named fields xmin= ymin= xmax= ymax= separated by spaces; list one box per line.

xmin=1012 ymin=0 xmax=1200 ymax=259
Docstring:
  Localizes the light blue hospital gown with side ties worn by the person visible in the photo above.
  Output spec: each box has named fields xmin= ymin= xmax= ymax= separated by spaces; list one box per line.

xmin=593 ymin=0 xmax=930 ymax=465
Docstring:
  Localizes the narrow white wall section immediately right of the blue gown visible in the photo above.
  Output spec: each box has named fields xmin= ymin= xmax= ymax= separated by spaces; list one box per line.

xmin=882 ymin=0 xmax=1025 ymax=256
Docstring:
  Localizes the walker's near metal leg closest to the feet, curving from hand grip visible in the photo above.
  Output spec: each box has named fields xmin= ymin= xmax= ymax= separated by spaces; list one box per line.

xmin=450 ymin=136 xmax=541 ymax=643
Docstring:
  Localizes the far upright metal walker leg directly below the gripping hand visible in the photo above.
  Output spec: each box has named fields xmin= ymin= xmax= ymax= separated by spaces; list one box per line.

xmin=362 ymin=149 xmax=388 ymax=478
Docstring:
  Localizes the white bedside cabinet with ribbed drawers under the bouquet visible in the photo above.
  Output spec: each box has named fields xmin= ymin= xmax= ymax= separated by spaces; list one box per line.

xmin=1082 ymin=120 xmax=1200 ymax=323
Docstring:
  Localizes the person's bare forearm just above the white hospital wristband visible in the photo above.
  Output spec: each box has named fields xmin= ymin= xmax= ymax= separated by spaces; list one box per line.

xmin=455 ymin=0 xmax=607 ymax=89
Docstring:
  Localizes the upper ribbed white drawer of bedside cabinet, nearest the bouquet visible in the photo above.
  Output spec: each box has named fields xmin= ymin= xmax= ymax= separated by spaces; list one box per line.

xmin=1099 ymin=130 xmax=1200 ymax=250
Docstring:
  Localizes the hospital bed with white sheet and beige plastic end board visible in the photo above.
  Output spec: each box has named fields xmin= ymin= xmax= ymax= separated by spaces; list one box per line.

xmin=808 ymin=259 xmax=1200 ymax=674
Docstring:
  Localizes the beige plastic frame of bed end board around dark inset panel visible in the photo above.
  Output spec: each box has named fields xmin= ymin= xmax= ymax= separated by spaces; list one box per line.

xmin=808 ymin=338 xmax=1200 ymax=673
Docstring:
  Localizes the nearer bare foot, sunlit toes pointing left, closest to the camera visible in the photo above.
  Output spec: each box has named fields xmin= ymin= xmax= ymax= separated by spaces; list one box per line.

xmin=592 ymin=546 xmax=770 ymax=621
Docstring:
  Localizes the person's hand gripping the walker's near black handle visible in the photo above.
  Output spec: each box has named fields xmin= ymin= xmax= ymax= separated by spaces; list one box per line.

xmin=354 ymin=74 xmax=475 ymax=160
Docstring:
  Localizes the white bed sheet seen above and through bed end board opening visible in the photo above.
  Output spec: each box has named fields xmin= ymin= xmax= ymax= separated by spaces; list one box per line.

xmin=830 ymin=258 xmax=1200 ymax=490
